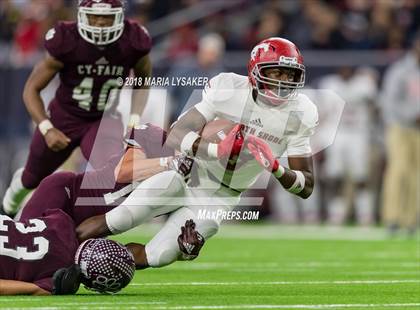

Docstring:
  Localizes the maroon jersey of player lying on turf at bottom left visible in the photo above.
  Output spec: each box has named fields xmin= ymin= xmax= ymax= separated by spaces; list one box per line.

xmin=0 ymin=209 xmax=79 ymax=291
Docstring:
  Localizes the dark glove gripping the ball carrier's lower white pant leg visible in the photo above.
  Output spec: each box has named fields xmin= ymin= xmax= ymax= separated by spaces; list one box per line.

xmin=178 ymin=220 xmax=205 ymax=260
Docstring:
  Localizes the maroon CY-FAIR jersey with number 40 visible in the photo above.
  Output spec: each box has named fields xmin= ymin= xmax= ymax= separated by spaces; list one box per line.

xmin=45 ymin=20 xmax=151 ymax=119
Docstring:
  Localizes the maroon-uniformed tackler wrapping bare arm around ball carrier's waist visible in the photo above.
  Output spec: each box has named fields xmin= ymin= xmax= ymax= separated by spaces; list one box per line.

xmin=12 ymin=124 xmax=204 ymax=268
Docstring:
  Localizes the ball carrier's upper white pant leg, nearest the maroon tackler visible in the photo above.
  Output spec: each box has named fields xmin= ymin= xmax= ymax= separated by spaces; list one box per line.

xmin=105 ymin=171 xmax=185 ymax=234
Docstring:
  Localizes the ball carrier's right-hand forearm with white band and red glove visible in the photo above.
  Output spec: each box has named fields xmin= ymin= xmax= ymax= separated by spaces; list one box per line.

xmin=246 ymin=136 xmax=314 ymax=199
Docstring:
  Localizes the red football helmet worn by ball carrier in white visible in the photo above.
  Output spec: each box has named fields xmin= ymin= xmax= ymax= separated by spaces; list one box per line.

xmin=248 ymin=37 xmax=305 ymax=105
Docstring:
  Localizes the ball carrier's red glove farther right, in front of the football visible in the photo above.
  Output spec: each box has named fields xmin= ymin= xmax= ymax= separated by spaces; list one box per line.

xmin=247 ymin=136 xmax=280 ymax=172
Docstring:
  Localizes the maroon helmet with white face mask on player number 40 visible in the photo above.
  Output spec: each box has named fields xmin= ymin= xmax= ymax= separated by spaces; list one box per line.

xmin=77 ymin=0 xmax=124 ymax=45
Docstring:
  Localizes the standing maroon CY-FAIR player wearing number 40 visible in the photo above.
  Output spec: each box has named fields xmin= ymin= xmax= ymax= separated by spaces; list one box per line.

xmin=3 ymin=0 xmax=152 ymax=215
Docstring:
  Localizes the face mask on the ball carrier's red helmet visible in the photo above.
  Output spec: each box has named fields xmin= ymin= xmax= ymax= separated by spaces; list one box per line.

xmin=252 ymin=63 xmax=305 ymax=105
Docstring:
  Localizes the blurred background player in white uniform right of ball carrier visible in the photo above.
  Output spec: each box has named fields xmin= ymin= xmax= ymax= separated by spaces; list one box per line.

xmin=319 ymin=67 xmax=378 ymax=225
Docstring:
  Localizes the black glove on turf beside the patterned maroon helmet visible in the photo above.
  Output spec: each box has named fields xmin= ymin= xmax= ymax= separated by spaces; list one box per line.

xmin=51 ymin=264 xmax=81 ymax=295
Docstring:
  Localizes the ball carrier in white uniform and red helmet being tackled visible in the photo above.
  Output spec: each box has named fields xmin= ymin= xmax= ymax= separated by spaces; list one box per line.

xmin=78 ymin=38 xmax=318 ymax=267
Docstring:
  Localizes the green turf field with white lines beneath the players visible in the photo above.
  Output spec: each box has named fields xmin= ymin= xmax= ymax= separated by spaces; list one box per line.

xmin=0 ymin=225 xmax=420 ymax=310
